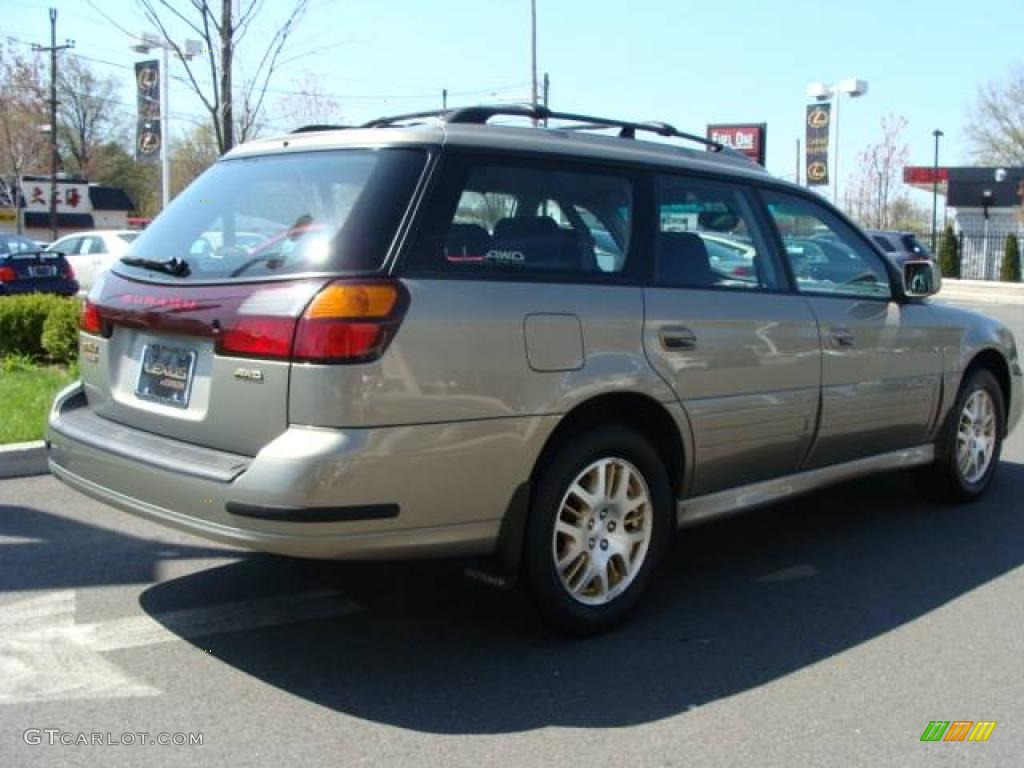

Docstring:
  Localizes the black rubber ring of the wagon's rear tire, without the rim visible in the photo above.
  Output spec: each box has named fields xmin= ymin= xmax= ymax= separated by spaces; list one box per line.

xmin=524 ymin=426 xmax=675 ymax=635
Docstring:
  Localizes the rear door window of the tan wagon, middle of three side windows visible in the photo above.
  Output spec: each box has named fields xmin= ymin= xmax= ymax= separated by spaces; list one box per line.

xmin=656 ymin=176 xmax=785 ymax=291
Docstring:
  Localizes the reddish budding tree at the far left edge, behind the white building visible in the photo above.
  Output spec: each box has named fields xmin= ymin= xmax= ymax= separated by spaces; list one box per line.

xmin=0 ymin=44 xmax=50 ymax=231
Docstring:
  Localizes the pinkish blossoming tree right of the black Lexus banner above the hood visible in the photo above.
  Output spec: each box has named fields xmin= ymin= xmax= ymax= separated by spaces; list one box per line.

xmin=847 ymin=115 xmax=910 ymax=229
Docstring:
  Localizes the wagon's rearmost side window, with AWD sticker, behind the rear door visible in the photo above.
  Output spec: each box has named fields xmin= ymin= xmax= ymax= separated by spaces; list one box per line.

xmin=411 ymin=158 xmax=633 ymax=278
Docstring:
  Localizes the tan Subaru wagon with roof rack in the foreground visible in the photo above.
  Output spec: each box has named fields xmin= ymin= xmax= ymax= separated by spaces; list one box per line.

xmin=47 ymin=106 xmax=1024 ymax=633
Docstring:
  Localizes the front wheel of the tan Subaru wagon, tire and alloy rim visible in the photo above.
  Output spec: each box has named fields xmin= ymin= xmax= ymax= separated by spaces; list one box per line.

xmin=923 ymin=368 xmax=1007 ymax=502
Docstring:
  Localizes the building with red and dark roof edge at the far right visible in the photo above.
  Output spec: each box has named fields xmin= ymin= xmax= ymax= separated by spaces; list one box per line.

xmin=903 ymin=166 xmax=1024 ymax=280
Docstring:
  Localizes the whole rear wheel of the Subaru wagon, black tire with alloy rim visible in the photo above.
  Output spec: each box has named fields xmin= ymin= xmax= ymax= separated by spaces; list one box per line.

xmin=523 ymin=426 xmax=674 ymax=635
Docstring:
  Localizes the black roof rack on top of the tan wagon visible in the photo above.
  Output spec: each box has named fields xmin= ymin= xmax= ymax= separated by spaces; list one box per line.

xmin=362 ymin=104 xmax=749 ymax=160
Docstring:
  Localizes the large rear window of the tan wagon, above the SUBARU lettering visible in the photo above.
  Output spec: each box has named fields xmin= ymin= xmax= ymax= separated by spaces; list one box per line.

xmin=116 ymin=148 xmax=426 ymax=282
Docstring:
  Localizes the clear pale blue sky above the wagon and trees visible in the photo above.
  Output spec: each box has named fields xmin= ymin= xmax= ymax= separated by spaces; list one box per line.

xmin=0 ymin=0 xmax=1024 ymax=201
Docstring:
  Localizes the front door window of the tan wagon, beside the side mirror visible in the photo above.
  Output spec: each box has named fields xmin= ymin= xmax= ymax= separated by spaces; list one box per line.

xmin=764 ymin=191 xmax=892 ymax=299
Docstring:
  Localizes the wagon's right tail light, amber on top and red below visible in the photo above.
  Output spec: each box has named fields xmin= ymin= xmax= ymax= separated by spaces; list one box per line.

xmin=292 ymin=281 xmax=408 ymax=362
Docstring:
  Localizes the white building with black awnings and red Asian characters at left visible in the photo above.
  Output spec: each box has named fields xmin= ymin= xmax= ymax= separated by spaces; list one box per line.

xmin=0 ymin=176 xmax=135 ymax=241
